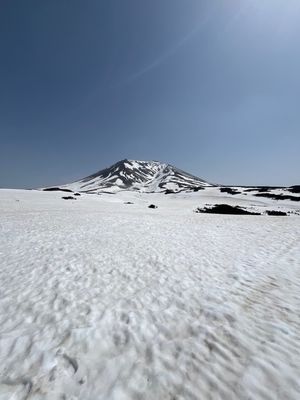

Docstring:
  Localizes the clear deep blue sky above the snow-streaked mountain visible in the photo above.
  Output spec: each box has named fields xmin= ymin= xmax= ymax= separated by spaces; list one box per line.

xmin=0 ymin=0 xmax=300 ymax=188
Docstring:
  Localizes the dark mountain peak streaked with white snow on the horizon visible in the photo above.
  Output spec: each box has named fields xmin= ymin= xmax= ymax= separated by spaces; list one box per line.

xmin=60 ymin=159 xmax=213 ymax=193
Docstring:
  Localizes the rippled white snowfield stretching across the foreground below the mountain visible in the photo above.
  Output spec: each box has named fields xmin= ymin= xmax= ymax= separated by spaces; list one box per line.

xmin=0 ymin=188 xmax=300 ymax=400
